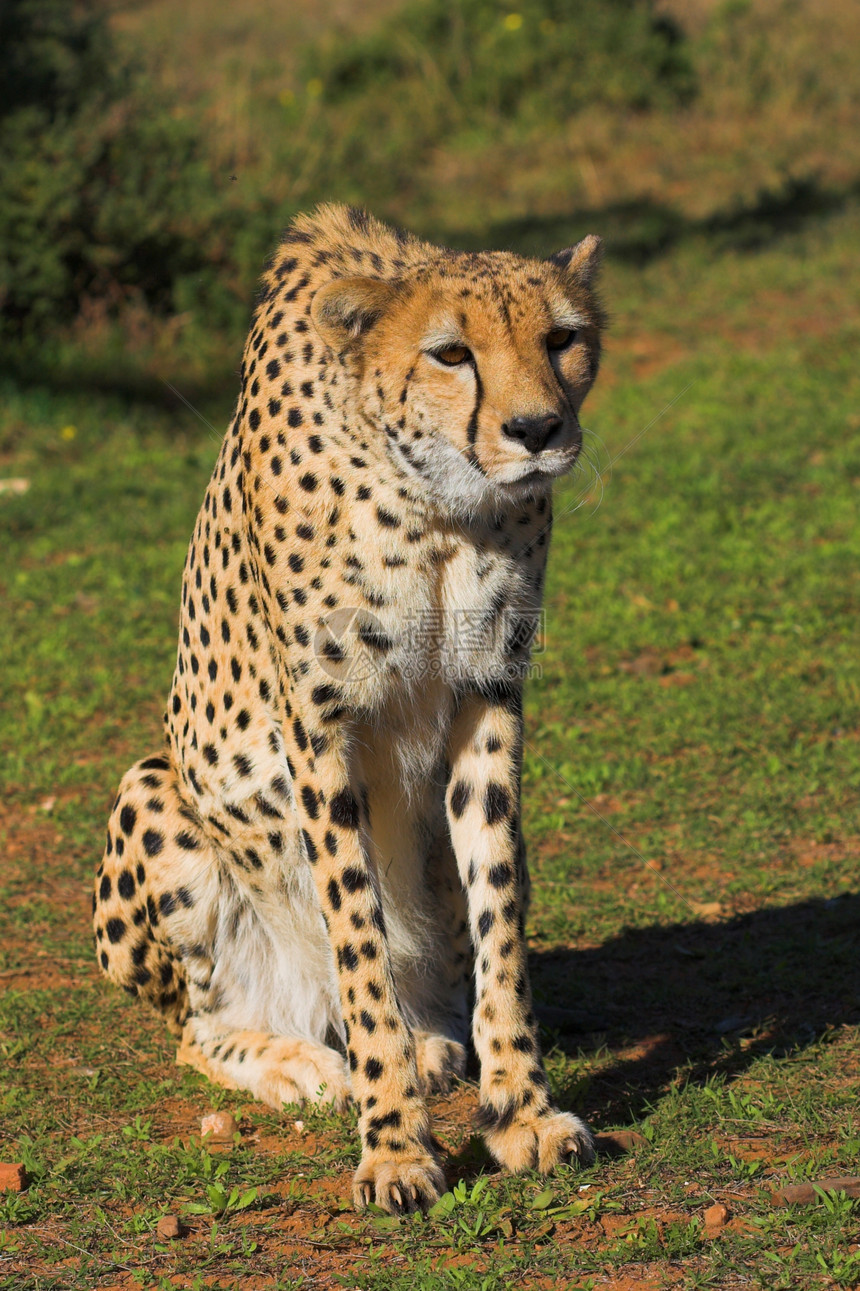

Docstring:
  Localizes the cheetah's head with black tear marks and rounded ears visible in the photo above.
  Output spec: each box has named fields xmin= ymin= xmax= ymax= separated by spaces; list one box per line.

xmin=311 ymin=236 xmax=603 ymax=514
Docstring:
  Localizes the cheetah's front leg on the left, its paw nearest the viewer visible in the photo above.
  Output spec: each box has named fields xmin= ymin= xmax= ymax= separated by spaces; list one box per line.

xmin=284 ymin=723 xmax=445 ymax=1214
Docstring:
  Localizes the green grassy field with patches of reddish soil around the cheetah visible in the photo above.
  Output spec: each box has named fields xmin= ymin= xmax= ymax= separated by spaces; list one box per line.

xmin=0 ymin=0 xmax=860 ymax=1291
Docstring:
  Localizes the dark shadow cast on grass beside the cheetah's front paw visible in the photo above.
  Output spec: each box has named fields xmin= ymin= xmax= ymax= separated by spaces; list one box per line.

xmin=531 ymin=893 xmax=860 ymax=1127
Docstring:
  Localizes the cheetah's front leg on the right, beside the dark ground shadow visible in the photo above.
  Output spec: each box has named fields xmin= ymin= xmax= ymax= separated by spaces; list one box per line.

xmin=447 ymin=687 xmax=594 ymax=1171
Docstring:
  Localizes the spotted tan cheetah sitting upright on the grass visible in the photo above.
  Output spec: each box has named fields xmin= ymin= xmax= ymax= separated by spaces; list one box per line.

xmin=94 ymin=205 xmax=603 ymax=1214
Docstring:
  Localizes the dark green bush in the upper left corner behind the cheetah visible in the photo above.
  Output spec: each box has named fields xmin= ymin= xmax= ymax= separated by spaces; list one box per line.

xmin=0 ymin=0 xmax=251 ymax=334
